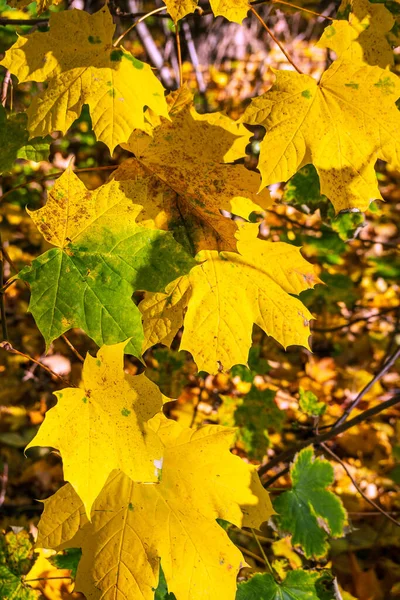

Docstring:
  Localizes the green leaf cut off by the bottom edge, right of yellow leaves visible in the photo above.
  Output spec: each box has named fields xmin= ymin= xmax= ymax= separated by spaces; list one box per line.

xmin=236 ymin=569 xmax=319 ymax=600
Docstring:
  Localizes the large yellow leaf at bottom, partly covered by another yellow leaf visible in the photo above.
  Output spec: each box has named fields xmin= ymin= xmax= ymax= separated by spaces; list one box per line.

xmin=38 ymin=417 xmax=273 ymax=600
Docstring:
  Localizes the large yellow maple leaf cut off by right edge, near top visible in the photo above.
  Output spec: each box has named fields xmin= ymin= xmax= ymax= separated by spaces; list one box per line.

xmin=242 ymin=60 xmax=400 ymax=211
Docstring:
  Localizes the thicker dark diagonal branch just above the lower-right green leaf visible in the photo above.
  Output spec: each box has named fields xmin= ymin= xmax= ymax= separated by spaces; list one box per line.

xmin=258 ymin=394 xmax=400 ymax=478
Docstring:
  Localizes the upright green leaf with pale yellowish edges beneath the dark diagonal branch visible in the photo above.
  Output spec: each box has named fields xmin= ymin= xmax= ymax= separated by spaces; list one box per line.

xmin=274 ymin=447 xmax=346 ymax=558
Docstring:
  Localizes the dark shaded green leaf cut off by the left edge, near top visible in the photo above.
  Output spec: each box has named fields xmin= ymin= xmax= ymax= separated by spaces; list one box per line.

xmin=0 ymin=105 xmax=51 ymax=173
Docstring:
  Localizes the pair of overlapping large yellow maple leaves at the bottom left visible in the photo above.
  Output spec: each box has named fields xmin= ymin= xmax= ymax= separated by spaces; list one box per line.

xmin=28 ymin=344 xmax=273 ymax=600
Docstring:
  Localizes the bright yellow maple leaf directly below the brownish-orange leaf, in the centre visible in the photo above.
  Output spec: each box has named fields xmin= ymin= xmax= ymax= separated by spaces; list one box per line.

xmin=139 ymin=223 xmax=320 ymax=373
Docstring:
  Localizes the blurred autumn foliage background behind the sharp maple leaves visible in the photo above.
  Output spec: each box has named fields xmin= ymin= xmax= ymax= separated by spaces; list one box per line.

xmin=0 ymin=0 xmax=400 ymax=600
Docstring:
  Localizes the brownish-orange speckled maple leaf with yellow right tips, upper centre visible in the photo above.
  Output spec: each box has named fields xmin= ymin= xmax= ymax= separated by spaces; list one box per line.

xmin=117 ymin=88 xmax=272 ymax=253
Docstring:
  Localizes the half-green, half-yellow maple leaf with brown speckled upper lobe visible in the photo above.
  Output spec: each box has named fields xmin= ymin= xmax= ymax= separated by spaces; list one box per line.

xmin=19 ymin=169 xmax=194 ymax=356
